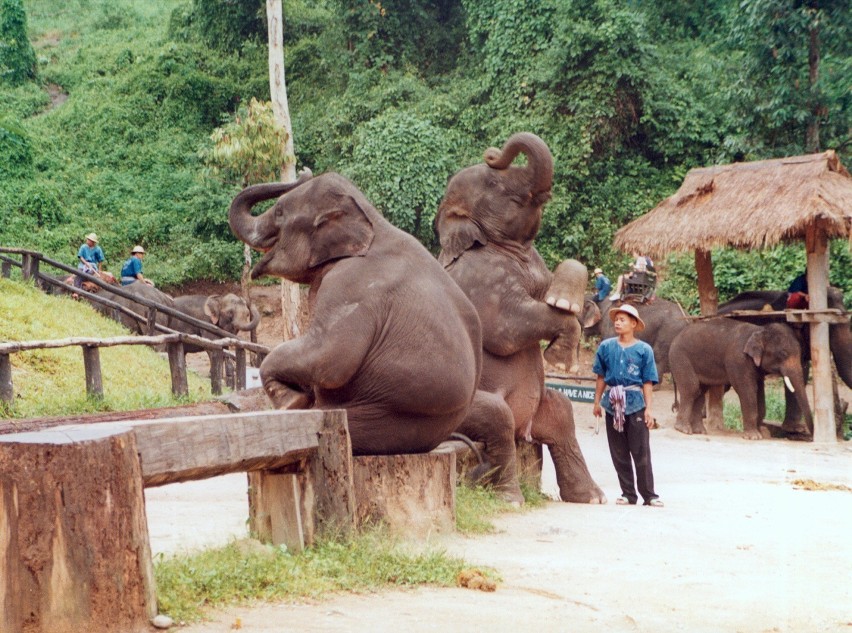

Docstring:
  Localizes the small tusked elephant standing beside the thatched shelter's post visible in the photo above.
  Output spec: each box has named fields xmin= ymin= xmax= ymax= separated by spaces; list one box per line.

xmin=669 ymin=318 xmax=813 ymax=440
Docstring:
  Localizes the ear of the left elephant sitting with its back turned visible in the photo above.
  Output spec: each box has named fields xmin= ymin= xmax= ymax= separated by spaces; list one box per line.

xmin=308 ymin=194 xmax=375 ymax=268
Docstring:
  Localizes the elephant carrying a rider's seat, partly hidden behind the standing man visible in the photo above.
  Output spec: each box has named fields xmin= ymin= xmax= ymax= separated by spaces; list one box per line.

xmin=583 ymin=295 xmax=689 ymax=378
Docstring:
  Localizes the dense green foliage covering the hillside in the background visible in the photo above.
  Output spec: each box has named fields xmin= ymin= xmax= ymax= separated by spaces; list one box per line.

xmin=0 ymin=0 xmax=852 ymax=306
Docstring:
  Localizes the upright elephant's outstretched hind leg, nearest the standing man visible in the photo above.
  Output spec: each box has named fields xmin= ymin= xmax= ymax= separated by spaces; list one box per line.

xmin=532 ymin=389 xmax=606 ymax=503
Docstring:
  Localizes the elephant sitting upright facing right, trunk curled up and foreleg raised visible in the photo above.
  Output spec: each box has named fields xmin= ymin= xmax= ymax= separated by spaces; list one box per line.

xmin=435 ymin=132 xmax=606 ymax=503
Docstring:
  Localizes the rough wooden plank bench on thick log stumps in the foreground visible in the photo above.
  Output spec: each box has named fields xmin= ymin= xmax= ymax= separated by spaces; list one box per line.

xmin=0 ymin=411 xmax=355 ymax=633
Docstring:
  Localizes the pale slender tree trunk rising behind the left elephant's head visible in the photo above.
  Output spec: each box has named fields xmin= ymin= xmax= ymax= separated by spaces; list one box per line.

xmin=266 ymin=0 xmax=301 ymax=338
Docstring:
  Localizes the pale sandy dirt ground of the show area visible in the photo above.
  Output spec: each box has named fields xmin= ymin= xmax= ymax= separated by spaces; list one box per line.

xmin=145 ymin=287 xmax=852 ymax=633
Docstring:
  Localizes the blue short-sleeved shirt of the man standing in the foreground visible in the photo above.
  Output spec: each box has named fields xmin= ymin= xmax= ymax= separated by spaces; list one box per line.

xmin=592 ymin=336 xmax=660 ymax=415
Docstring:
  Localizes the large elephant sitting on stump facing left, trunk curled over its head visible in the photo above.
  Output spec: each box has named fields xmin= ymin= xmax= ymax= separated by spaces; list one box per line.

xmin=229 ymin=171 xmax=523 ymax=504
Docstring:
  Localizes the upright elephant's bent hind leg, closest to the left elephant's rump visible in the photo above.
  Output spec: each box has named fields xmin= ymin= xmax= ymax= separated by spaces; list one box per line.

xmin=456 ymin=390 xmax=524 ymax=505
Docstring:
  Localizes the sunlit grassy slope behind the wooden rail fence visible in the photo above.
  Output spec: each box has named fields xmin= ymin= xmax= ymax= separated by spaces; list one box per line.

xmin=0 ymin=279 xmax=211 ymax=418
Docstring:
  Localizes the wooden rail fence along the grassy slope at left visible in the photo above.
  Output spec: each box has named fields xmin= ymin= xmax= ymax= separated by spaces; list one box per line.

xmin=0 ymin=247 xmax=269 ymax=404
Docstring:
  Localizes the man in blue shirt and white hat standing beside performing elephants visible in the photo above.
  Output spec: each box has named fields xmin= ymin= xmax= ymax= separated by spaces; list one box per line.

xmin=592 ymin=303 xmax=663 ymax=507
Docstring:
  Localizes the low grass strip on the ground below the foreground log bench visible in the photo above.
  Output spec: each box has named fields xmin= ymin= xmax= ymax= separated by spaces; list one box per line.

xmin=154 ymin=529 xmax=494 ymax=622
